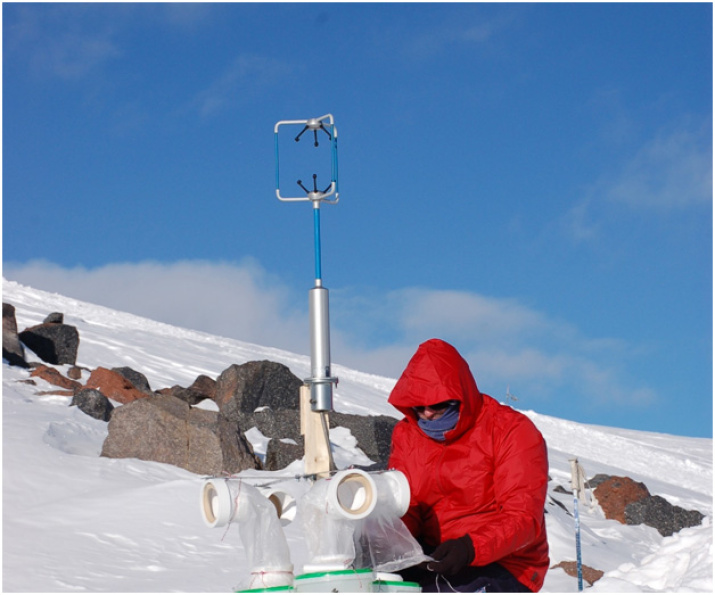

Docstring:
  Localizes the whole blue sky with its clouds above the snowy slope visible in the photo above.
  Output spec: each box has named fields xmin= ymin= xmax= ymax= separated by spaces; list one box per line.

xmin=2 ymin=3 xmax=713 ymax=437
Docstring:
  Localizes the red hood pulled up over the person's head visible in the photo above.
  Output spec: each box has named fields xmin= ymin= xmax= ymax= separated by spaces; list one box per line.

xmin=388 ymin=339 xmax=483 ymax=441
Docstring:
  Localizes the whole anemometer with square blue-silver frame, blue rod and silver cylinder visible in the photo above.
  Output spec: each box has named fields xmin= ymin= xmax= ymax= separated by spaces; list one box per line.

xmin=273 ymin=114 xmax=338 ymax=411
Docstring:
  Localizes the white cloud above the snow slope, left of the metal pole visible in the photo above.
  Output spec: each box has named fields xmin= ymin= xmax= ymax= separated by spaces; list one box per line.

xmin=4 ymin=260 xmax=308 ymax=353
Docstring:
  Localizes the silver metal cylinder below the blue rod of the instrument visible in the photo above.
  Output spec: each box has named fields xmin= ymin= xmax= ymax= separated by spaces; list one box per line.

xmin=308 ymin=287 xmax=335 ymax=411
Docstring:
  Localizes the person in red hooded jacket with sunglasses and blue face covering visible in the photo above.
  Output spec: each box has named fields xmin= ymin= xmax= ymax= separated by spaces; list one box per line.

xmin=388 ymin=339 xmax=549 ymax=592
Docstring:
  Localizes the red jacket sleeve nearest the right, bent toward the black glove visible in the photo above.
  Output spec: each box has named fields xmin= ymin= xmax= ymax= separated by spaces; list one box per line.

xmin=469 ymin=417 xmax=549 ymax=566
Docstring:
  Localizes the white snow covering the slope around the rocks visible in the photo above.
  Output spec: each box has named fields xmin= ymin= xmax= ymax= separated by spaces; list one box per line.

xmin=2 ymin=280 xmax=713 ymax=593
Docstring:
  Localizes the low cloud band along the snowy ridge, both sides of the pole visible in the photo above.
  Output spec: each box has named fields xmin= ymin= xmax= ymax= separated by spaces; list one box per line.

xmin=4 ymin=260 xmax=656 ymax=414
